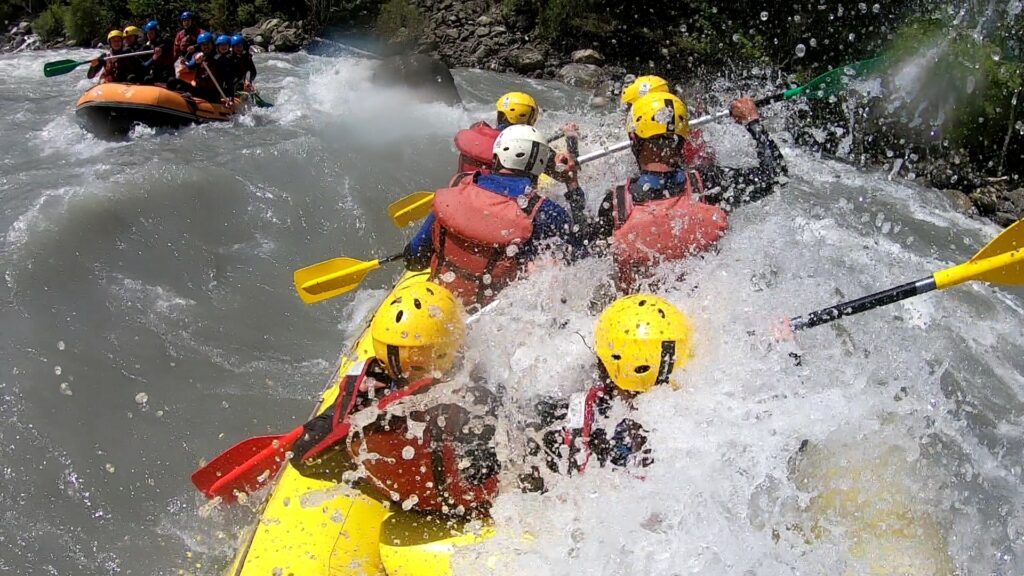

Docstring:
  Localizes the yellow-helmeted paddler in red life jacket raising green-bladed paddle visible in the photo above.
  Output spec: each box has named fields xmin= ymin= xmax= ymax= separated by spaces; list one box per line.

xmin=566 ymin=92 xmax=786 ymax=292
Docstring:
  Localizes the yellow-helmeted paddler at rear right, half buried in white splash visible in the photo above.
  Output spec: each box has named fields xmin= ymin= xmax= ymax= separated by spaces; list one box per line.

xmin=520 ymin=294 xmax=691 ymax=481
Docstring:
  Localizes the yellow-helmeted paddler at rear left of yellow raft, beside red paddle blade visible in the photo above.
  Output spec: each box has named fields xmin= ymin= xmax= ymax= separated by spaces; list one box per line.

xmin=291 ymin=282 xmax=499 ymax=515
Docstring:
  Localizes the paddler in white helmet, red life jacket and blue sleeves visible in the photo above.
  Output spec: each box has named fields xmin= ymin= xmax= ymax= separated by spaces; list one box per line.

xmin=404 ymin=124 xmax=583 ymax=307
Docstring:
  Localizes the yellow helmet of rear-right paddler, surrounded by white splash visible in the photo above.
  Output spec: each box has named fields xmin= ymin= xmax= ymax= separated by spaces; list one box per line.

xmin=595 ymin=294 xmax=691 ymax=392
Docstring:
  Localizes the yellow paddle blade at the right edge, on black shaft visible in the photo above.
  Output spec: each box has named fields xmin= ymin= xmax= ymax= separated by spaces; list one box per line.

xmin=935 ymin=220 xmax=1024 ymax=290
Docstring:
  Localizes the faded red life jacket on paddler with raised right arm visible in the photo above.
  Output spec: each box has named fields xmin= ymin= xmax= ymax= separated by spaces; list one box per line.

xmin=611 ymin=172 xmax=729 ymax=286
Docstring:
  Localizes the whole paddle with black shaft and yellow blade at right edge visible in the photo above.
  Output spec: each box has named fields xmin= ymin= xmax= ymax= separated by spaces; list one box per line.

xmin=790 ymin=220 xmax=1024 ymax=331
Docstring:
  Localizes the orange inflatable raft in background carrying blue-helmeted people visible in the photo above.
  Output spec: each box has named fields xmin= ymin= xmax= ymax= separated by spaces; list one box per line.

xmin=75 ymin=82 xmax=248 ymax=138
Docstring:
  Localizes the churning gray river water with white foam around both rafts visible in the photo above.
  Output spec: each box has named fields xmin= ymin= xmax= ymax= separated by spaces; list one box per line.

xmin=0 ymin=47 xmax=1024 ymax=574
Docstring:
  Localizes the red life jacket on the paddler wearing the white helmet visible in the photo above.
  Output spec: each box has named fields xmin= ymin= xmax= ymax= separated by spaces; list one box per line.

xmin=430 ymin=174 xmax=546 ymax=306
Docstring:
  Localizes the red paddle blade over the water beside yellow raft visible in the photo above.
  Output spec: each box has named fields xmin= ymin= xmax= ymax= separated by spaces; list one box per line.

xmin=191 ymin=426 xmax=302 ymax=502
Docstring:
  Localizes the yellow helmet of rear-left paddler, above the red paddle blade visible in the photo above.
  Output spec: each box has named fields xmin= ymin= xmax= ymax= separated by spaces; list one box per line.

xmin=370 ymin=282 xmax=466 ymax=380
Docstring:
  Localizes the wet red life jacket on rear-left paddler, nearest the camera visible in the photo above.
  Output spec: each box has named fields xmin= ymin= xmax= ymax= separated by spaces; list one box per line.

xmin=302 ymin=360 xmax=498 ymax=512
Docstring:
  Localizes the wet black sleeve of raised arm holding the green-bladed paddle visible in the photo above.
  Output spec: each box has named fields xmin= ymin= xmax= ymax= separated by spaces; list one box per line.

xmin=700 ymin=120 xmax=788 ymax=210
